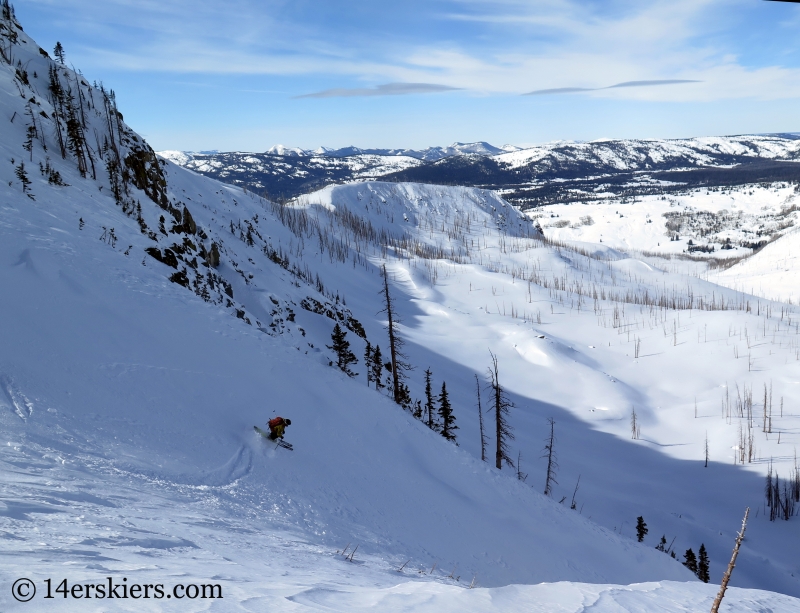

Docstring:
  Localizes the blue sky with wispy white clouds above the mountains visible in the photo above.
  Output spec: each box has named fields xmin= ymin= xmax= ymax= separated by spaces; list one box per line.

xmin=15 ymin=0 xmax=800 ymax=151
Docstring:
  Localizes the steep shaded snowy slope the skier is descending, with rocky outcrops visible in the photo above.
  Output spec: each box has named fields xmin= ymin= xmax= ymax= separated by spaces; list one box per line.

xmin=0 ymin=5 xmax=732 ymax=607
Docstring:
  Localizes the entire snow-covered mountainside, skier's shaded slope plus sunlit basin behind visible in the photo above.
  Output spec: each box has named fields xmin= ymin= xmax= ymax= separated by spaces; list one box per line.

xmin=0 ymin=4 xmax=800 ymax=613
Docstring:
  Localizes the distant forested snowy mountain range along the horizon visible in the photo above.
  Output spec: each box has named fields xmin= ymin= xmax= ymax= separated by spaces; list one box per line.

xmin=160 ymin=133 xmax=800 ymax=208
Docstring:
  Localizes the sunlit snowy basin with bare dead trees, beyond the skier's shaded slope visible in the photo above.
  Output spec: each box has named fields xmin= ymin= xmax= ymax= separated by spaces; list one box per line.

xmin=272 ymin=183 xmax=798 ymax=593
